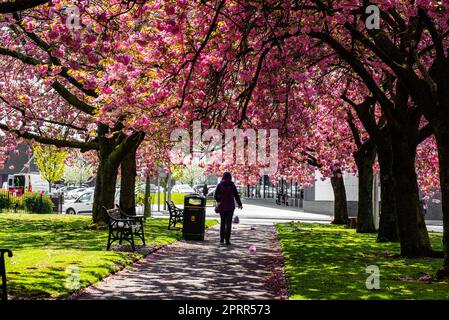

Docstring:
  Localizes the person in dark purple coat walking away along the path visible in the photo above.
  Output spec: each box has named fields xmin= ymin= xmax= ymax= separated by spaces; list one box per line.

xmin=214 ymin=172 xmax=243 ymax=245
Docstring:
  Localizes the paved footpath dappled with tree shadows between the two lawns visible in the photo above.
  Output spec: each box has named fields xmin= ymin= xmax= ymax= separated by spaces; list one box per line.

xmin=72 ymin=224 xmax=287 ymax=300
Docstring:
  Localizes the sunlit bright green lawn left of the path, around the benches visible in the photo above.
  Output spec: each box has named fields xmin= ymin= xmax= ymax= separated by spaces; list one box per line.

xmin=0 ymin=213 xmax=216 ymax=299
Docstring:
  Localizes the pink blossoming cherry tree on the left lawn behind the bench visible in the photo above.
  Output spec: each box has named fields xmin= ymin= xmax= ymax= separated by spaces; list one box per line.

xmin=0 ymin=1 xmax=180 ymax=222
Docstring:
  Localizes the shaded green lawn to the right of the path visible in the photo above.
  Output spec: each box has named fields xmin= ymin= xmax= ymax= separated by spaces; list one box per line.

xmin=276 ymin=223 xmax=449 ymax=299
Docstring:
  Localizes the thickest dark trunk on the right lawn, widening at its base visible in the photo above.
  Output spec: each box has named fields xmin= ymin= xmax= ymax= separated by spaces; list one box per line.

xmin=391 ymin=131 xmax=433 ymax=257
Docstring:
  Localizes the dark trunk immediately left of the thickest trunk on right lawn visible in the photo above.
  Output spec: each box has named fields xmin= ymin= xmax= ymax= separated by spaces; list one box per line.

xmin=377 ymin=143 xmax=399 ymax=242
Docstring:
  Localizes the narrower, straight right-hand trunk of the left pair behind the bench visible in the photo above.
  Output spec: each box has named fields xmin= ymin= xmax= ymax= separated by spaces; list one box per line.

xmin=120 ymin=146 xmax=137 ymax=215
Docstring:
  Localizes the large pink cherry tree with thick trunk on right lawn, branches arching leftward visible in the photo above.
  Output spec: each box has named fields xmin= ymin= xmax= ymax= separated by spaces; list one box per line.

xmin=155 ymin=1 xmax=447 ymax=262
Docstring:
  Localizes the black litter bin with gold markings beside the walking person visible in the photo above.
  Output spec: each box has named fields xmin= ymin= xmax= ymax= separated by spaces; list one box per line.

xmin=182 ymin=194 xmax=206 ymax=241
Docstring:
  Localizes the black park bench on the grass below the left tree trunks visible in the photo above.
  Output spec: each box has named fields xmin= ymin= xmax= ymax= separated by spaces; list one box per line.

xmin=103 ymin=207 xmax=145 ymax=251
